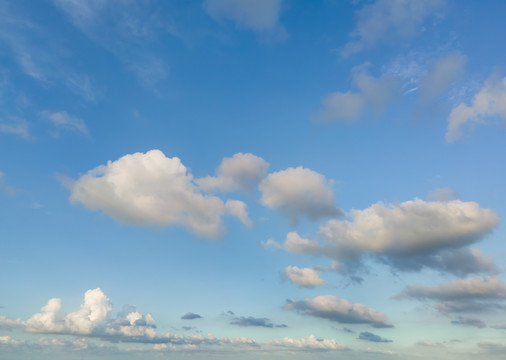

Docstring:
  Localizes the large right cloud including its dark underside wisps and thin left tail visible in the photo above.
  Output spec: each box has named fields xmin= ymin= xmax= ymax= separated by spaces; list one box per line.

xmin=272 ymin=199 xmax=499 ymax=276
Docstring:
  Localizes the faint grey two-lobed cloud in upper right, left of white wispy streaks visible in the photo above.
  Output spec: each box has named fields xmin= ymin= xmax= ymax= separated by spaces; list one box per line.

xmin=315 ymin=63 xmax=399 ymax=123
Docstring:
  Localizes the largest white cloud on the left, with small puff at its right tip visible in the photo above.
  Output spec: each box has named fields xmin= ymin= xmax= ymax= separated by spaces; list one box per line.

xmin=70 ymin=150 xmax=249 ymax=237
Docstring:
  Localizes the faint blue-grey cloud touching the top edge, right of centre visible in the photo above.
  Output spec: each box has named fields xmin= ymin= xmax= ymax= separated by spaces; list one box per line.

xmin=341 ymin=0 xmax=445 ymax=56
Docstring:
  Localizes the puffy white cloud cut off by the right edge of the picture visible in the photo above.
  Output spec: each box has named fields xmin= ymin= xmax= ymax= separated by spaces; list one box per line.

xmin=446 ymin=77 xmax=506 ymax=143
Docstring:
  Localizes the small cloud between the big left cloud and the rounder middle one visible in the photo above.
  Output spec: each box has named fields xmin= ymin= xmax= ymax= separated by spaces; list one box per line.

xmin=195 ymin=153 xmax=269 ymax=194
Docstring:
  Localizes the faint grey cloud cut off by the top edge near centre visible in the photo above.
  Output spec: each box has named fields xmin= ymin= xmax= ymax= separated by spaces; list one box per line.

xmin=204 ymin=0 xmax=282 ymax=32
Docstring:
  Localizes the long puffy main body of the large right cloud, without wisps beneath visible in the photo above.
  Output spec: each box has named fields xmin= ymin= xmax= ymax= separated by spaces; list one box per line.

xmin=320 ymin=199 xmax=499 ymax=260
